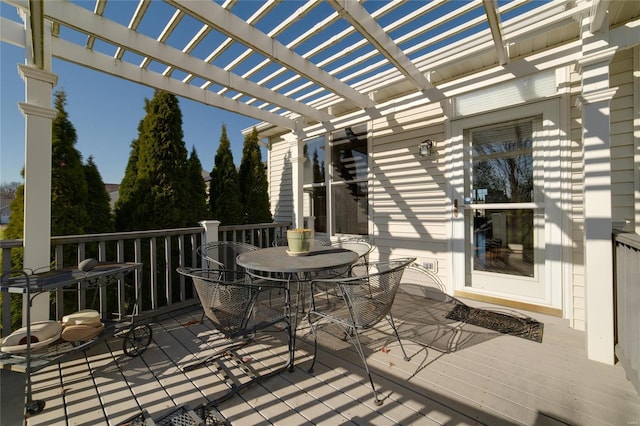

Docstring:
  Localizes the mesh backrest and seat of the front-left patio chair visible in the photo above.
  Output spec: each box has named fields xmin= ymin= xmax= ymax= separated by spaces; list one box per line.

xmin=177 ymin=268 xmax=284 ymax=338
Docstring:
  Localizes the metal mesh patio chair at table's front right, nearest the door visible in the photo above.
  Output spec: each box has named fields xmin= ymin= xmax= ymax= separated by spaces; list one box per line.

xmin=308 ymin=258 xmax=415 ymax=405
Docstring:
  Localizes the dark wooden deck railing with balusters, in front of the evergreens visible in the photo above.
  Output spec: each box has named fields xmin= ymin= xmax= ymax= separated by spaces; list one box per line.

xmin=0 ymin=222 xmax=290 ymax=336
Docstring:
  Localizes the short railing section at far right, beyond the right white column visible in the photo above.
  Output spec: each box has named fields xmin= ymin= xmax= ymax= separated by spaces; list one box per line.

xmin=614 ymin=233 xmax=640 ymax=394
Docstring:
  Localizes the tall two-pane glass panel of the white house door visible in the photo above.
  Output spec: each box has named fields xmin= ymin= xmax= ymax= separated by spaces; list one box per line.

xmin=465 ymin=118 xmax=545 ymax=297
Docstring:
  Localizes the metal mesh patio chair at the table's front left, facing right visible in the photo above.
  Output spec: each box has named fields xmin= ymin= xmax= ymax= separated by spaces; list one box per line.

xmin=177 ymin=268 xmax=292 ymax=402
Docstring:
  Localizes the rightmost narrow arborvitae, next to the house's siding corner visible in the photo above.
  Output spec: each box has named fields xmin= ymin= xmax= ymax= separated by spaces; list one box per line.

xmin=239 ymin=128 xmax=272 ymax=223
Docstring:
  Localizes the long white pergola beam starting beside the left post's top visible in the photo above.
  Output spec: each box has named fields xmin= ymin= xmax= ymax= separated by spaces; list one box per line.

xmin=45 ymin=1 xmax=331 ymax=121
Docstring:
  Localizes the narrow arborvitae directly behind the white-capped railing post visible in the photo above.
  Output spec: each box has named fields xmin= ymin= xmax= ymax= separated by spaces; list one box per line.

xmin=209 ymin=125 xmax=244 ymax=225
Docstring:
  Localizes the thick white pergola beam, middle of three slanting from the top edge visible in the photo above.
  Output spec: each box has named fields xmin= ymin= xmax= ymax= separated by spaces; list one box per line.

xmin=166 ymin=0 xmax=373 ymax=108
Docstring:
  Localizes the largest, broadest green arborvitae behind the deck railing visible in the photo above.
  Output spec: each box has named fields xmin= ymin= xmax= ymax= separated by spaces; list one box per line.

xmin=115 ymin=90 xmax=192 ymax=231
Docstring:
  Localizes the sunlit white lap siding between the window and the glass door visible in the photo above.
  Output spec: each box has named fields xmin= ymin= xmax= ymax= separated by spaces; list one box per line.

xmin=369 ymin=104 xmax=450 ymax=282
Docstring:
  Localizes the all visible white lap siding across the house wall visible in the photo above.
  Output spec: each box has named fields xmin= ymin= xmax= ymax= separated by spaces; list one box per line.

xmin=262 ymin=49 xmax=638 ymax=330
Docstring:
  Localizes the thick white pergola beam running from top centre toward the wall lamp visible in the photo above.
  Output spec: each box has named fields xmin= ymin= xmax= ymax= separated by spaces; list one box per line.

xmin=329 ymin=0 xmax=433 ymax=91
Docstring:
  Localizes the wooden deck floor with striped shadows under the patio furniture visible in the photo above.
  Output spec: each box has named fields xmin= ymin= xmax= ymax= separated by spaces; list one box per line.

xmin=21 ymin=288 xmax=640 ymax=426
